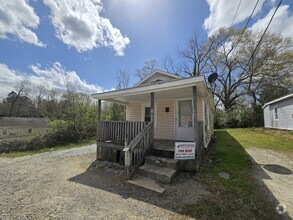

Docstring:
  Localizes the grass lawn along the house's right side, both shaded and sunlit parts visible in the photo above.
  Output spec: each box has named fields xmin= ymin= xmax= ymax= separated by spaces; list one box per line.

xmin=182 ymin=128 xmax=293 ymax=219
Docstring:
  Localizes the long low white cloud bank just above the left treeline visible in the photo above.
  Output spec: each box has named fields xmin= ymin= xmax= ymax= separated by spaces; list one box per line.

xmin=0 ymin=62 xmax=102 ymax=98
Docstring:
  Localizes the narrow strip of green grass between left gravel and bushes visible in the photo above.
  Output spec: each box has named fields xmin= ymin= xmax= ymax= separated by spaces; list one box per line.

xmin=0 ymin=139 xmax=96 ymax=158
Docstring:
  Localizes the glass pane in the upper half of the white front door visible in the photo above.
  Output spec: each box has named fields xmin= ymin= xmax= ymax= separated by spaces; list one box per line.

xmin=178 ymin=100 xmax=192 ymax=127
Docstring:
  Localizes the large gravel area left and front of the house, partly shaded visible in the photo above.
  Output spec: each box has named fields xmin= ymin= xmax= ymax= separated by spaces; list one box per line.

xmin=0 ymin=145 xmax=206 ymax=220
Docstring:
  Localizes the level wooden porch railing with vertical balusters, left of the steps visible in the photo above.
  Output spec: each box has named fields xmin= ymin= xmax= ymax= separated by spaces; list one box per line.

xmin=97 ymin=121 xmax=147 ymax=145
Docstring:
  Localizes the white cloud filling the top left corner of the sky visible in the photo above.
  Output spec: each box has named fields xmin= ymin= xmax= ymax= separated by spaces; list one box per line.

xmin=0 ymin=0 xmax=45 ymax=47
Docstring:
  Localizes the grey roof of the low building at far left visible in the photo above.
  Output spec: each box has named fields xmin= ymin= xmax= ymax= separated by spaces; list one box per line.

xmin=0 ymin=117 xmax=48 ymax=128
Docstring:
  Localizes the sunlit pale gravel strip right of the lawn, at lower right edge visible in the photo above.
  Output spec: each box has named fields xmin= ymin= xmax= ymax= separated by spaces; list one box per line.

xmin=246 ymin=148 xmax=293 ymax=218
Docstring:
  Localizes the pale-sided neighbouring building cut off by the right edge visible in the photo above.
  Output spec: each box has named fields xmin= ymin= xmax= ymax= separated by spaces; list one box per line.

xmin=262 ymin=93 xmax=293 ymax=130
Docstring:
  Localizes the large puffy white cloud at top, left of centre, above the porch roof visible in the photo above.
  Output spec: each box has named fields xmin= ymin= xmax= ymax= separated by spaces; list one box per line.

xmin=44 ymin=0 xmax=130 ymax=56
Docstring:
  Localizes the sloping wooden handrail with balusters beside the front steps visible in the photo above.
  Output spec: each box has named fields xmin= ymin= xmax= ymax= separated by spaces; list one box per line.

xmin=123 ymin=122 xmax=153 ymax=178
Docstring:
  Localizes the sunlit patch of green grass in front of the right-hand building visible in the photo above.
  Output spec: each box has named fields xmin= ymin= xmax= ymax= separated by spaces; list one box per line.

xmin=227 ymin=128 xmax=293 ymax=152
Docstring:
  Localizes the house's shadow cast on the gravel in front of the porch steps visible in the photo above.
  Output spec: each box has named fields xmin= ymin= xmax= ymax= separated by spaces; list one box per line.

xmin=68 ymin=161 xmax=206 ymax=217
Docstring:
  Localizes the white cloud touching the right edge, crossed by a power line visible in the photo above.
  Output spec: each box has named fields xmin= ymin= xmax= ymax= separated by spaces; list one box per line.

xmin=251 ymin=5 xmax=293 ymax=37
